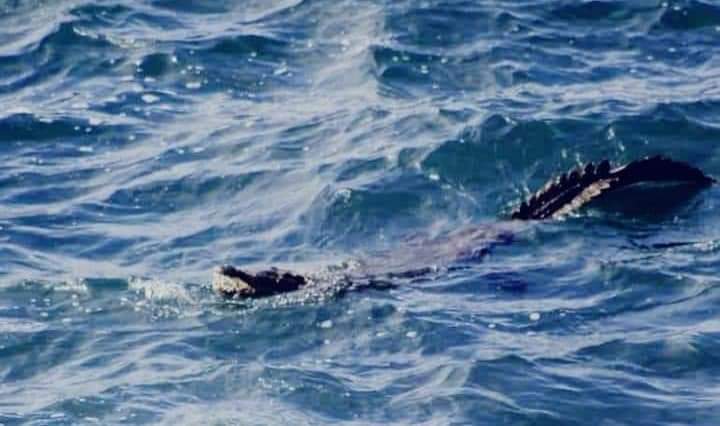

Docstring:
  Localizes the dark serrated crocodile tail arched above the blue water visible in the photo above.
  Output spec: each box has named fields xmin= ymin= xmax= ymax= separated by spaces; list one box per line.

xmin=511 ymin=155 xmax=715 ymax=220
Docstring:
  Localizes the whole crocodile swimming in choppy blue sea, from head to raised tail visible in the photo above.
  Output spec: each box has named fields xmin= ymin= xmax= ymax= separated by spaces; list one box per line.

xmin=213 ymin=156 xmax=715 ymax=298
